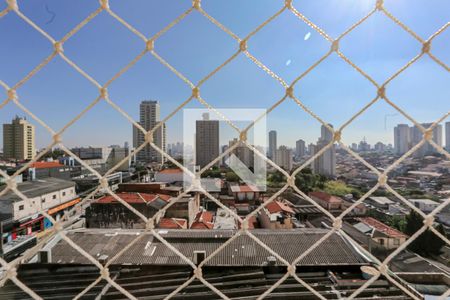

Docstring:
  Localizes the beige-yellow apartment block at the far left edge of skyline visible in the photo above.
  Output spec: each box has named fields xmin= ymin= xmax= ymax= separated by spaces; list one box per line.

xmin=3 ymin=116 xmax=36 ymax=160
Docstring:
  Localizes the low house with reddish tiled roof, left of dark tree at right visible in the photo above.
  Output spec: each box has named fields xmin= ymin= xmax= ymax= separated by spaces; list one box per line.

xmin=354 ymin=217 xmax=408 ymax=250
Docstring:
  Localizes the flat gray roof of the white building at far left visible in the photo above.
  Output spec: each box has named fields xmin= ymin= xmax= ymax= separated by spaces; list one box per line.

xmin=0 ymin=177 xmax=75 ymax=201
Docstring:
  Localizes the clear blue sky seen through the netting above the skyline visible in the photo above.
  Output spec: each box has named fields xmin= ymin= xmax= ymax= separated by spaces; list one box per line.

xmin=0 ymin=0 xmax=450 ymax=148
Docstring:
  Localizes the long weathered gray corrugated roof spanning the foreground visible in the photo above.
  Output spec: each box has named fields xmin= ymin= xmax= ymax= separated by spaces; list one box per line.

xmin=51 ymin=228 xmax=366 ymax=266
